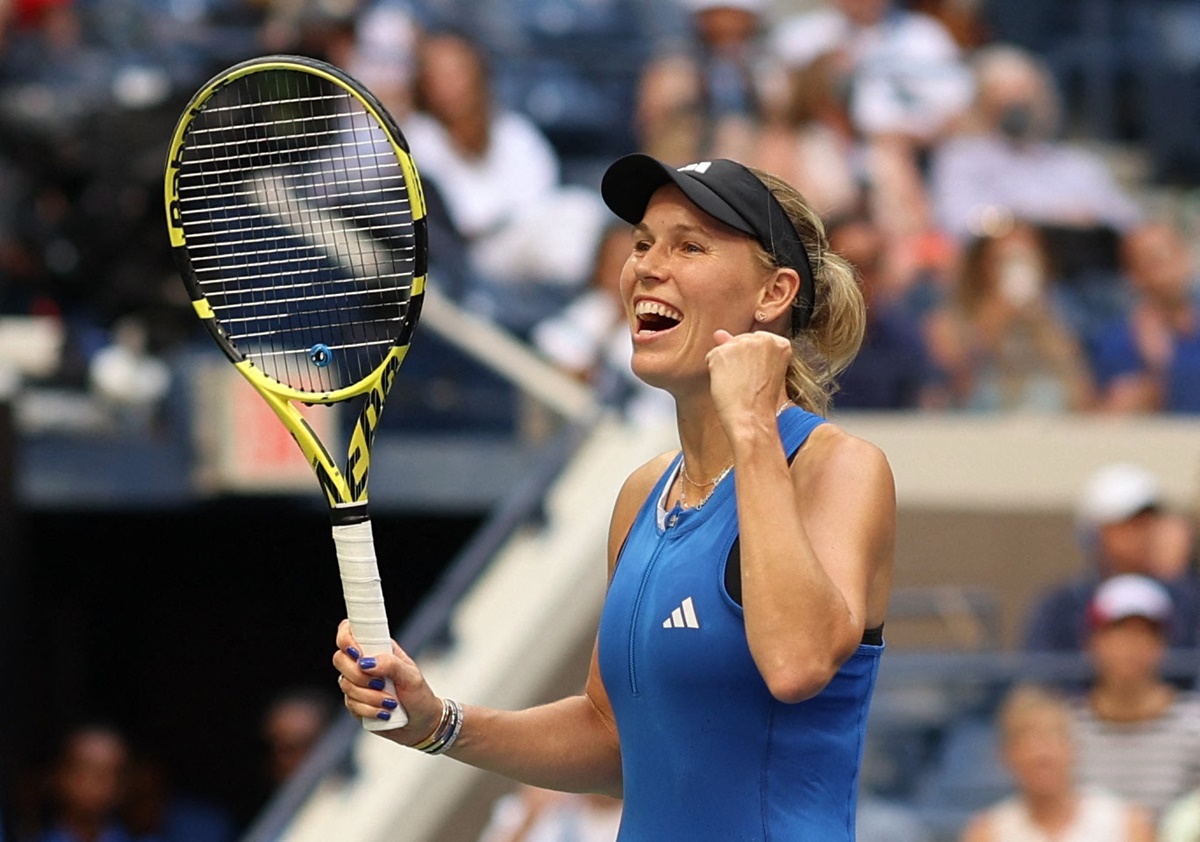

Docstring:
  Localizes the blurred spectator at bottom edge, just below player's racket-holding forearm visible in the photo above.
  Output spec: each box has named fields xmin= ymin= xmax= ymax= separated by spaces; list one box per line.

xmin=479 ymin=784 xmax=622 ymax=842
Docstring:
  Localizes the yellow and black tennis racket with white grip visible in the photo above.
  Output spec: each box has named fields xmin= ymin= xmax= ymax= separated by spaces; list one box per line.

xmin=164 ymin=55 xmax=428 ymax=730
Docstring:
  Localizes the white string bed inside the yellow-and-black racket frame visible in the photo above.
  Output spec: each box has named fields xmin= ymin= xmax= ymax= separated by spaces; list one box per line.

xmin=179 ymin=70 xmax=416 ymax=392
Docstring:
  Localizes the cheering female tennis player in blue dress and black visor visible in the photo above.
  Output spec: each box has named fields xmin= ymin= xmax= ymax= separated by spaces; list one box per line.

xmin=334 ymin=155 xmax=895 ymax=842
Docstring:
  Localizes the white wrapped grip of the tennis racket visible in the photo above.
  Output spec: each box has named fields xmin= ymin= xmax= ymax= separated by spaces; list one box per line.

xmin=334 ymin=521 xmax=408 ymax=730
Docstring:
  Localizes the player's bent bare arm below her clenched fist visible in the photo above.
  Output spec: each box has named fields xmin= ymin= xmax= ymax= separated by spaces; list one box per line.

xmin=720 ymin=426 xmax=877 ymax=700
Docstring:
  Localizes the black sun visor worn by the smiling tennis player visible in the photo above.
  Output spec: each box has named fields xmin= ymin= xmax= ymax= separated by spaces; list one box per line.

xmin=600 ymin=154 xmax=816 ymax=332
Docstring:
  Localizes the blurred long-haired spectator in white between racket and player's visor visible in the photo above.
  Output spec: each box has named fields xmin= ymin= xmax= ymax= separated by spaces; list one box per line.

xmin=404 ymin=32 xmax=607 ymax=335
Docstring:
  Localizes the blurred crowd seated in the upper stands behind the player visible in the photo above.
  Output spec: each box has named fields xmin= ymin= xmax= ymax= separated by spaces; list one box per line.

xmin=0 ymin=0 xmax=1200 ymax=429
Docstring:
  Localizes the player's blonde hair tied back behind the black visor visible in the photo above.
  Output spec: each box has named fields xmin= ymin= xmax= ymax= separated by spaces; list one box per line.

xmin=749 ymin=167 xmax=866 ymax=415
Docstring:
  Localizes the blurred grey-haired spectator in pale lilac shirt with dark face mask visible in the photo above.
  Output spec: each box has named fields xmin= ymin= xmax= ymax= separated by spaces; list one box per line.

xmin=929 ymin=43 xmax=1141 ymax=339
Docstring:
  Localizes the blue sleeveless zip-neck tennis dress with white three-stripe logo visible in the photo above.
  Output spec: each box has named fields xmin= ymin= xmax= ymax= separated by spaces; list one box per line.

xmin=599 ymin=408 xmax=883 ymax=842
